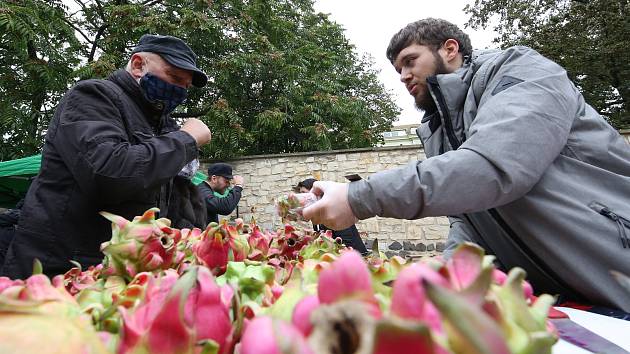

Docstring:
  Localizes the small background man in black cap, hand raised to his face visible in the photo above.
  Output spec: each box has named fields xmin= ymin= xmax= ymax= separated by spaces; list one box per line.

xmin=197 ymin=162 xmax=243 ymax=223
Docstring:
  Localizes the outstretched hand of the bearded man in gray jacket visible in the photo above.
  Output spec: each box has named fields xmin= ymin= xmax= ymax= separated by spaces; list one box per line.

xmin=302 ymin=181 xmax=359 ymax=230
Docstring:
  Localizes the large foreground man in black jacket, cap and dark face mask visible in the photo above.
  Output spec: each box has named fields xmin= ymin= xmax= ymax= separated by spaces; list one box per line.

xmin=0 ymin=35 xmax=210 ymax=278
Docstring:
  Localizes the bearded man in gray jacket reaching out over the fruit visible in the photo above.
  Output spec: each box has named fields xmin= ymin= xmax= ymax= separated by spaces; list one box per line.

xmin=304 ymin=18 xmax=630 ymax=311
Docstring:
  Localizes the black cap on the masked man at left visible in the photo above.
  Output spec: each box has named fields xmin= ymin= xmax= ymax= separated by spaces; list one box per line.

xmin=131 ymin=34 xmax=208 ymax=87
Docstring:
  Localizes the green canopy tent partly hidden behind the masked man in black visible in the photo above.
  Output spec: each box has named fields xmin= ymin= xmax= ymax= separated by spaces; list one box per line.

xmin=0 ymin=155 xmax=212 ymax=208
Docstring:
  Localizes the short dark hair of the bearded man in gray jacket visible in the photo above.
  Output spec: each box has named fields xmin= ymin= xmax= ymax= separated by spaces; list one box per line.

xmin=386 ymin=18 xmax=472 ymax=64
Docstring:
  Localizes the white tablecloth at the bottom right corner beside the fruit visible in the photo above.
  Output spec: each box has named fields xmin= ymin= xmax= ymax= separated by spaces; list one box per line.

xmin=552 ymin=307 xmax=630 ymax=354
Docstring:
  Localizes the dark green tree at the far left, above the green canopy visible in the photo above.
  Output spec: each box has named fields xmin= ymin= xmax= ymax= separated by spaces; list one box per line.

xmin=0 ymin=0 xmax=81 ymax=160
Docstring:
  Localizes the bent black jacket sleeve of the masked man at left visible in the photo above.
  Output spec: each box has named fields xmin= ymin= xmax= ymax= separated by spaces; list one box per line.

xmin=47 ymin=80 xmax=197 ymax=201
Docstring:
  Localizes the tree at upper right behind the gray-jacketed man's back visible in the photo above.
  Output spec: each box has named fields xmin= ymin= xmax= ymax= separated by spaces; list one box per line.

xmin=464 ymin=0 xmax=630 ymax=129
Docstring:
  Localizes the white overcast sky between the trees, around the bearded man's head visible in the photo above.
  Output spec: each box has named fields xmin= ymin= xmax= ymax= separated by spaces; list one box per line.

xmin=315 ymin=0 xmax=495 ymax=125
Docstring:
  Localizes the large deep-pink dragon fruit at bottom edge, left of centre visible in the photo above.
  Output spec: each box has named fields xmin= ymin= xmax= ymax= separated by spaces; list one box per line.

xmin=118 ymin=267 xmax=232 ymax=354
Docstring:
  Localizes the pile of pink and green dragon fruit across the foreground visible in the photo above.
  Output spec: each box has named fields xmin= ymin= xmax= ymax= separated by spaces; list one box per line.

xmin=0 ymin=209 xmax=557 ymax=354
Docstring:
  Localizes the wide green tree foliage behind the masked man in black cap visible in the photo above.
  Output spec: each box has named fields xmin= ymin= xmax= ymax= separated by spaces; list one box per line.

xmin=0 ymin=0 xmax=398 ymax=159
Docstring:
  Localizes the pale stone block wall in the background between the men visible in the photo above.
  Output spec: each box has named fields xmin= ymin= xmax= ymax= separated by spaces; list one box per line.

xmin=202 ymin=145 xmax=449 ymax=256
